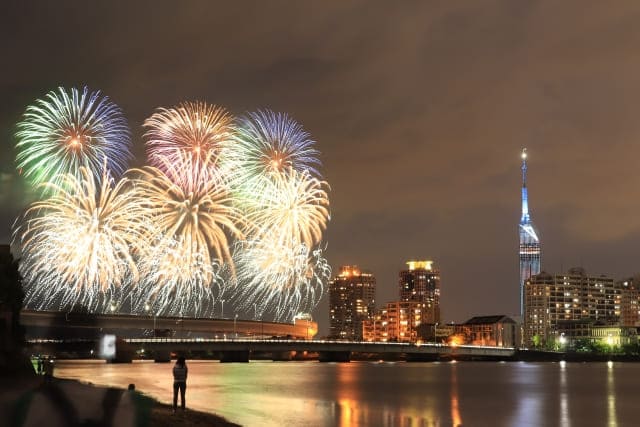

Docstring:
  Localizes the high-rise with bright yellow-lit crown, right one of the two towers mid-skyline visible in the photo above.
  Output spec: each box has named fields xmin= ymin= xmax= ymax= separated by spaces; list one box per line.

xmin=398 ymin=261 xmax=440 ymax=323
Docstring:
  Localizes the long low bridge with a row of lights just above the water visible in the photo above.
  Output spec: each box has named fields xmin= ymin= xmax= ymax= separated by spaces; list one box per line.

xmin=28 ymin=338 xmax=516 ymax=362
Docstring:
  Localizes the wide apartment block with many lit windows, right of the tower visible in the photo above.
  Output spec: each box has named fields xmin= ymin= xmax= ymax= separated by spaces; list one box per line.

xmin=524 ymin=268 xmax=624 ymax=345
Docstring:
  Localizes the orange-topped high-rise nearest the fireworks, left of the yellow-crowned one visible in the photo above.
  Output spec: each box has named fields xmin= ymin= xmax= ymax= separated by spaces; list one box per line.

xmin=329 ymin=265 xmax=376 ymax=341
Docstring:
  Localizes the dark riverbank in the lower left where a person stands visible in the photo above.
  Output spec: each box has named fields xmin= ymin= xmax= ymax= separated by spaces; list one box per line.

xmin=0 ymin=375 xmax=239 ymax=427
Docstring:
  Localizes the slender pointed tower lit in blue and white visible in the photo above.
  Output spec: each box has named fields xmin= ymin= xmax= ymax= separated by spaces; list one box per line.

xmin=519 ymin=148 xmax=541 ymax=319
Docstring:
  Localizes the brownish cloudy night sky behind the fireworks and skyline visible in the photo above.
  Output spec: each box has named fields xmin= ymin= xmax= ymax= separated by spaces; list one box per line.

xmin=0 ymin=0 xmax=640 ymax=333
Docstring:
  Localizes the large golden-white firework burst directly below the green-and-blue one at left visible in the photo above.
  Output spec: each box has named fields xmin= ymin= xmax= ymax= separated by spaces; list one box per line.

xmin=14 ymin=167 xmax=150 ymax=311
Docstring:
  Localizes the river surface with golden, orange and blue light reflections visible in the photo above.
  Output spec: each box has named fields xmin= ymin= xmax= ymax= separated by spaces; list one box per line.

xmin=56 ymin=361 xmax=640 ymax=427
